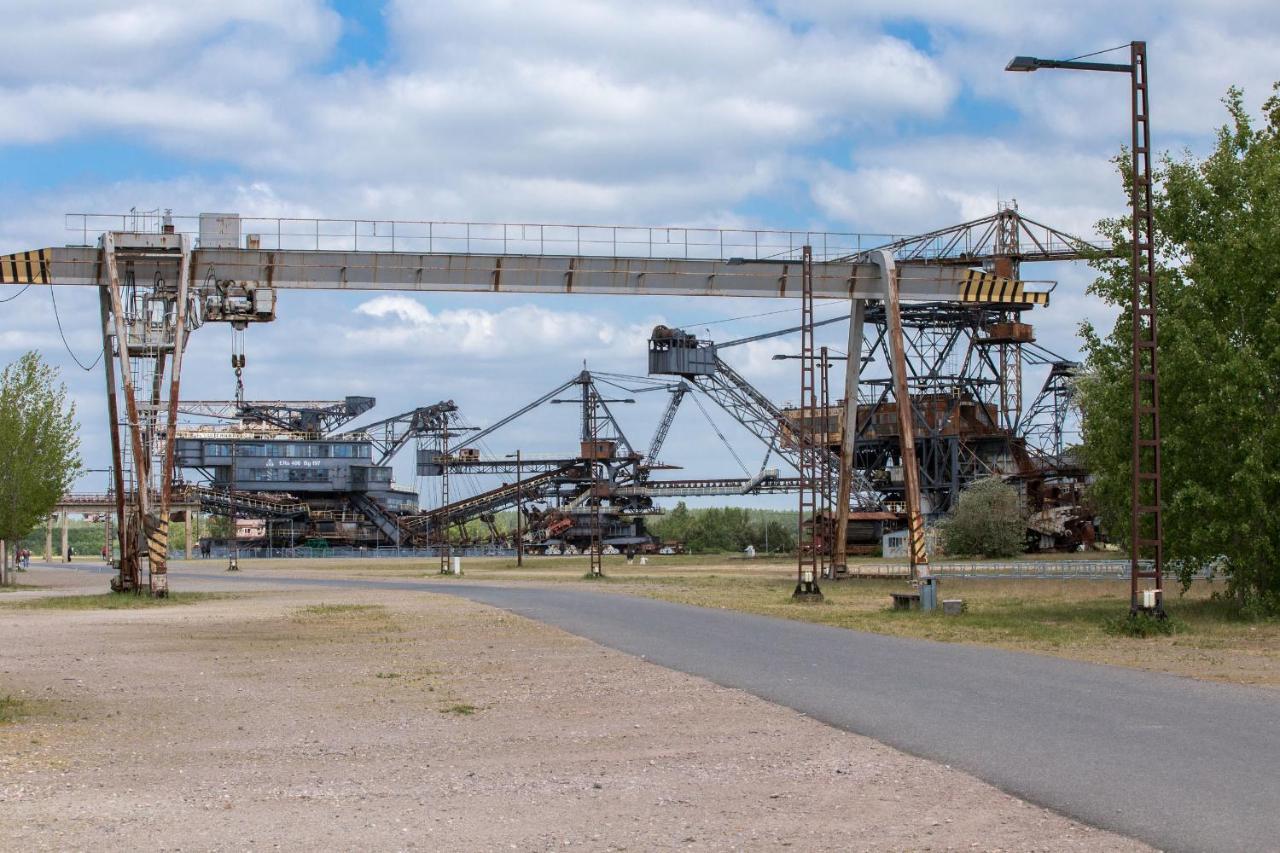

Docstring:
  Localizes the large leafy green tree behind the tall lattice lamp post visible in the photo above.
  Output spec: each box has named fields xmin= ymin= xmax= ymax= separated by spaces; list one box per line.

xmin=1080 ymin=88 xmax=1280 ymax=612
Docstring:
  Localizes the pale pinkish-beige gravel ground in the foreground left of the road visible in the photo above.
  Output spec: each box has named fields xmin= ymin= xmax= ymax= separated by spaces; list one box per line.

xmin=0 ymin=570 xmax=1147 ymax=850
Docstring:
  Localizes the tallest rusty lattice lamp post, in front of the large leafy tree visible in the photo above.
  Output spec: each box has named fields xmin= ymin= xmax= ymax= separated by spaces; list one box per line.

xmin=1005 ymin=41 xmax=1165 ymax=617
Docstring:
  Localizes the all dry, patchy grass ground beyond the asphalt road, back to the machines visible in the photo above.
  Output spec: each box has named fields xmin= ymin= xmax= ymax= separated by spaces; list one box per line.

xmin=177 ymin=555 xmax=1280 ymax=689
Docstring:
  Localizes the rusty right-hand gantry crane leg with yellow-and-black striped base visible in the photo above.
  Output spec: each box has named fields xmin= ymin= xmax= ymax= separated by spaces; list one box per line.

xmin=873 ymin=251 xmax=934 ymax=596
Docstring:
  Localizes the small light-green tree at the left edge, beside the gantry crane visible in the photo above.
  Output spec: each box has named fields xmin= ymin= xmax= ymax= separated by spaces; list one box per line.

xmin=0 ymin=352 xmax=81 ymax=581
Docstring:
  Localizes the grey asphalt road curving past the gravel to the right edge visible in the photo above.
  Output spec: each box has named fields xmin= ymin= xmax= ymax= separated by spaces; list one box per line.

xmin=45 ymin=560 xmax=1280 ymax=850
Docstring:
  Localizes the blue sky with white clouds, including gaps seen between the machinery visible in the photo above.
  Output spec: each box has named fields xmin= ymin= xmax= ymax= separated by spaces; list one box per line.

xmin=0 ymin=0 xmax=1280 ymax=502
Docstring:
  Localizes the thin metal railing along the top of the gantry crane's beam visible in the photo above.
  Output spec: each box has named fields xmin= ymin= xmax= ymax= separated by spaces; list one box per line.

xmin=65 ymin=213 xmax=905 ymax=260
